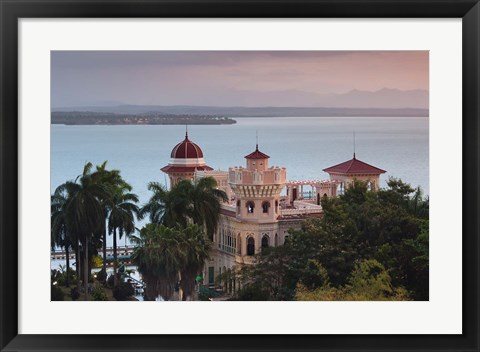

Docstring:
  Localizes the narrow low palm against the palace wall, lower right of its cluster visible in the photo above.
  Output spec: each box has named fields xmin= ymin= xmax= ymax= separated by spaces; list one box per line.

xmin=179 ymin=225 xmax=212 ymax=301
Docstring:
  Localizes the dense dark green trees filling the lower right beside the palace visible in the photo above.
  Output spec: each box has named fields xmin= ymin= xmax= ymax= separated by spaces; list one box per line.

xmin=236 ymin=178 xmax=429 ymax=300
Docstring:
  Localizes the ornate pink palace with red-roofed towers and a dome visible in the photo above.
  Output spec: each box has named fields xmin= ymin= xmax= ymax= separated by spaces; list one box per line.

xmin=161 ymin=134 xmax=385 ymax=291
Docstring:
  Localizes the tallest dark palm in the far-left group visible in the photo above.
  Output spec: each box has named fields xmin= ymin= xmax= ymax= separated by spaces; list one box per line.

xmin=57 ymin=163 xmax=108 ymax=300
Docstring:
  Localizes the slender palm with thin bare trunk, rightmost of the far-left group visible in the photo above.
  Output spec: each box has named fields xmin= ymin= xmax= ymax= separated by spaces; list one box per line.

xmin=108 ymin=182 xmax=140 ymax=287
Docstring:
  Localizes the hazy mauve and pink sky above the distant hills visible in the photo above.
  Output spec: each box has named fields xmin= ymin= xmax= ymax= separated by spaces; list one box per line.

xmin=51 ymin=51 xmax=429 ymax=108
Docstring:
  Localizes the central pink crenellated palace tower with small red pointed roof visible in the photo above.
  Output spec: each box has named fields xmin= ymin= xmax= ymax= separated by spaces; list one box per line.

xmin=228 ymin=144 xmax=287 ymax=222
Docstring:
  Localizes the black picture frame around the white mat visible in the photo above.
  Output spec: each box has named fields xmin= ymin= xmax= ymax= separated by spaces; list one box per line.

xmin=0 ymin=0 xmax=480 ymax=351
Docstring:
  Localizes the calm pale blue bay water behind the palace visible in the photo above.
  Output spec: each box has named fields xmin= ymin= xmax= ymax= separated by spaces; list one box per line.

xmin=51 ymin=117 xmax=429 ymax=244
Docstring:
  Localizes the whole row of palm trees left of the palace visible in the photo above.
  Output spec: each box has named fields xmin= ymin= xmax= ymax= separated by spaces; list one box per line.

xmin=51 ymin=162 xmax=227 ymax=300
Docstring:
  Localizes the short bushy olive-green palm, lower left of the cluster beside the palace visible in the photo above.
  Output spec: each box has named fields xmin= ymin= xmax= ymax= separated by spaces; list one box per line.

xmin=131 ymin=224 xmax=185 ymax=301
